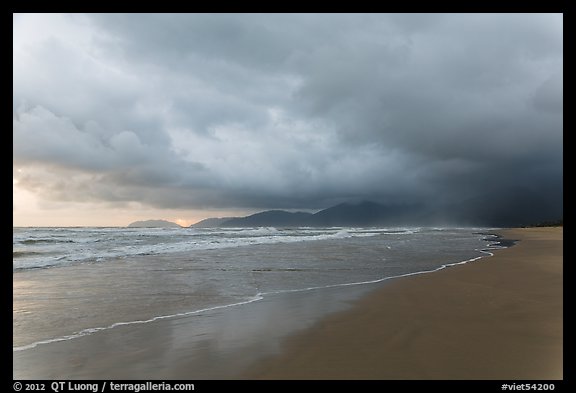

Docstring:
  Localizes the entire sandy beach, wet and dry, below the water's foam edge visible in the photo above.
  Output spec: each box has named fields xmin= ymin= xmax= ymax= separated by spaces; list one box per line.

xmin=13 ymin=228 xmax=563 ymax=380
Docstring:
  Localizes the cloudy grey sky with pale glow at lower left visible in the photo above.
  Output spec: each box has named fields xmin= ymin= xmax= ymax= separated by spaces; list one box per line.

xmin=13 ymin=14 xmax=563 ymax=226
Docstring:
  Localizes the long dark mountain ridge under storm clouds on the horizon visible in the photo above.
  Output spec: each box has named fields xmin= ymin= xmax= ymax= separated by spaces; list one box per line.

xmin=192 ymin=194 xmax=562 ymax=227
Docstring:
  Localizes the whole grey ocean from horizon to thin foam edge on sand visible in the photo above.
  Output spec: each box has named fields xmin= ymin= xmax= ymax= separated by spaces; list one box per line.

xmin=13 ymin=228 xmax=498 ymax=353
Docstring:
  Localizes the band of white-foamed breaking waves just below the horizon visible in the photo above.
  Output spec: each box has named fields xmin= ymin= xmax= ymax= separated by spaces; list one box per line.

xmin=13 ymin=227 xmax=400 ymax=270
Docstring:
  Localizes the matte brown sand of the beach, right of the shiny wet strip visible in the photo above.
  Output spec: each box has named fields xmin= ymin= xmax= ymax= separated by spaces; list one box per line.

xmin=242 ymin=228 xmax=563 ymax=380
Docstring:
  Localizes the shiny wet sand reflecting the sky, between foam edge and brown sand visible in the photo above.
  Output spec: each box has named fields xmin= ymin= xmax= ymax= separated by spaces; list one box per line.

xmin=13 ymin=274 xmax=378 ymax=380
